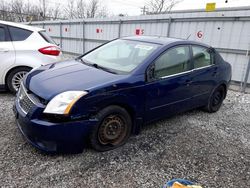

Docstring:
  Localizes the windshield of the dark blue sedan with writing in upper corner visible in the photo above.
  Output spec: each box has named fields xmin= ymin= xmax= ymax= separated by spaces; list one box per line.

xmin=82 ymin=40 xmax=159 ymax=74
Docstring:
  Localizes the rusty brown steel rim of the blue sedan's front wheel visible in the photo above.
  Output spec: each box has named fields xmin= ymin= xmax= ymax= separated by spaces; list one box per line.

xmin=98 ymin=114 xmax=127 ymax=146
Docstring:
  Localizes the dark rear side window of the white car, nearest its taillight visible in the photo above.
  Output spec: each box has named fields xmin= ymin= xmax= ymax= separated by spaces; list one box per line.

xmin=9 ymin=26 xmax=32 ymax=41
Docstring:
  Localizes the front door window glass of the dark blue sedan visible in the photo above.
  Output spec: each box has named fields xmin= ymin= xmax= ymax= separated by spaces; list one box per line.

xmin=154 ymin=46 xmax=190 ymax=79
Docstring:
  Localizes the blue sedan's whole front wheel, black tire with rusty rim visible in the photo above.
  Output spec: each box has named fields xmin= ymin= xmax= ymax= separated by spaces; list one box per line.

xmin=90 ymin=105 xmax=132 ymax=151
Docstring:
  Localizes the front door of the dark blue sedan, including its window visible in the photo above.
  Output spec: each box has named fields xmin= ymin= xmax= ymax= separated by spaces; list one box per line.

xmin=145 ymin=45 xmax=192 ymax=121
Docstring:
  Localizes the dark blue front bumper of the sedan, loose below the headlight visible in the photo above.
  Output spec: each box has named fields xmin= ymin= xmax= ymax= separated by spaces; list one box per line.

xmin=13 ymin=98 xmax=97 ymax=153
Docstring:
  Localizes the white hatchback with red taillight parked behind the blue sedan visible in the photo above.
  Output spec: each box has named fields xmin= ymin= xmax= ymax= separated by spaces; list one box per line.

xmin=0 ymin=21 xmax=62 ymax=93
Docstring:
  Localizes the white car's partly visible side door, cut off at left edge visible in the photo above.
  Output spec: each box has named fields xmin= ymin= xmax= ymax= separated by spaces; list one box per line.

xmin=0 ymin=24 xmax=16 ymax=84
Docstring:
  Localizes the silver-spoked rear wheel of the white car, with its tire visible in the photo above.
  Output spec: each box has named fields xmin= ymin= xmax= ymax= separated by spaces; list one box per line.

xmin=7 ymin=67 xmax=31 ymax=94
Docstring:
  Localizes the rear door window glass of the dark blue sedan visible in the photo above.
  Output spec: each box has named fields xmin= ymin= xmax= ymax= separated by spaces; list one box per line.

xmin=192 ymin=46 xmax=213 ymax=68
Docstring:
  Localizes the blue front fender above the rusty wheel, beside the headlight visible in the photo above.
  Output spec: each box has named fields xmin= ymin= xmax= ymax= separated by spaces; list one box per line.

xmin=71 ymin=86 xmax=145 ymax=133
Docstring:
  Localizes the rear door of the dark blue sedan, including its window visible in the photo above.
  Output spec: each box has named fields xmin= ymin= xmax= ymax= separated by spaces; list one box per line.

xmin=192 ymin=45 xmax=218 ymax=106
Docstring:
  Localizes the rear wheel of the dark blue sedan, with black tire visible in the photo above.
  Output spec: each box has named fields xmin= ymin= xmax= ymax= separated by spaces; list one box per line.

xmin=203 ymin=85 xmax=226 ymax=113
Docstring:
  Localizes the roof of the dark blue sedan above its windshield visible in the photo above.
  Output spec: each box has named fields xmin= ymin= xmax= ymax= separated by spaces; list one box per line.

xmin=121 ymin=36 xmax=210 ymax=48
